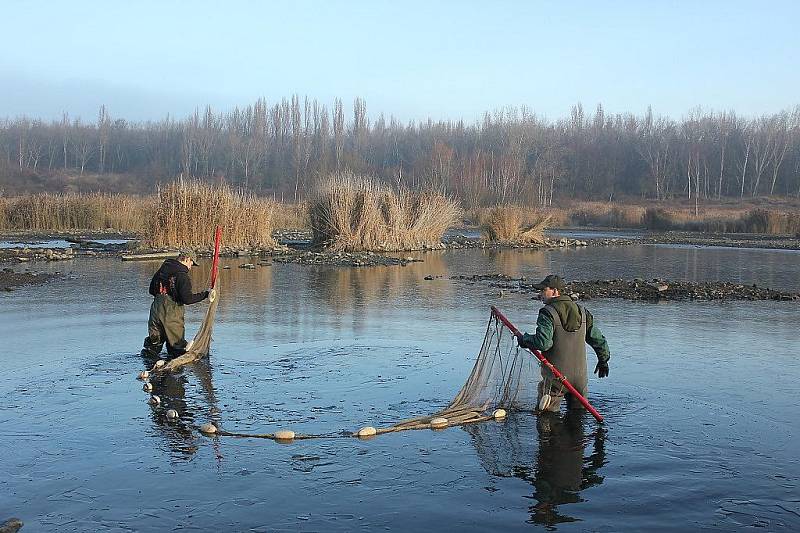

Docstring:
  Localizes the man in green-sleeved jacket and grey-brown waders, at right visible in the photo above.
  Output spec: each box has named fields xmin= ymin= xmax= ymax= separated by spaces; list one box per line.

xmin=518 ymin=274 xmax=611 ymax=413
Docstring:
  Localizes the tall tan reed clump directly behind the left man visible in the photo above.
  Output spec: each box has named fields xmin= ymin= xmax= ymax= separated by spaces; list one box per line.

xmin=148 ymin=179 xmax=276 ymax=248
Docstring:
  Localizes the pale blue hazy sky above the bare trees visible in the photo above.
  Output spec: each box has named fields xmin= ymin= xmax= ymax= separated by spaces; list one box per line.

xmin=0 ymin=0 xmax=800 ymax=123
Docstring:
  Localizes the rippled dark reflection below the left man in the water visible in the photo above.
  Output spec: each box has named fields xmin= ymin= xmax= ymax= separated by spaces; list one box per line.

xmin=141 ymin=354 xmax=219 ymax=460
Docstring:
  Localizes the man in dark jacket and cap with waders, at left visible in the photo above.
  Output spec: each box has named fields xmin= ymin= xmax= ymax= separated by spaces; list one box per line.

xmin=143 ymin=252 xmax=215 ymax=357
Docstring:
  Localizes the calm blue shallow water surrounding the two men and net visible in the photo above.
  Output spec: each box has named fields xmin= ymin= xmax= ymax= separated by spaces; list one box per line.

xmin=0 ymin=246 xmax=800 ymax=531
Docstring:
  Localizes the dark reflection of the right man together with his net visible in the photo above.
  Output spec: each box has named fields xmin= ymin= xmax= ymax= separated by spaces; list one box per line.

xmin=465 ymin=410 xmax=606 ymax=529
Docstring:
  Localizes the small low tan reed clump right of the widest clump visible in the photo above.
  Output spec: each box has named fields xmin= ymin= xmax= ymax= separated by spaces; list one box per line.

xmin=481 ymin=206 xmax=552 ymax=244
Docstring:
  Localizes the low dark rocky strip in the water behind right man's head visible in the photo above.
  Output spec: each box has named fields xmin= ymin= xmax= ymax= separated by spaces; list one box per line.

xmin=451 ymin=274 xmax=800 ymax=302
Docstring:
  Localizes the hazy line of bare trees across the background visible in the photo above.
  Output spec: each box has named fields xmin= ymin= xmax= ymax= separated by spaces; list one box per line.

xmin=0 ymin=95 xmax=800 ymax=207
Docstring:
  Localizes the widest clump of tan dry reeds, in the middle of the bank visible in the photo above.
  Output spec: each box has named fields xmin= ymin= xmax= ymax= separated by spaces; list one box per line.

xmin=309 ymin=173 xmax=462 ymax=252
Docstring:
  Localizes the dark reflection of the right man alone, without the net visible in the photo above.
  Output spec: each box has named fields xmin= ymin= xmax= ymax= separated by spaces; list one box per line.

xmin=531 ymin=411 xmax=605 ymax=525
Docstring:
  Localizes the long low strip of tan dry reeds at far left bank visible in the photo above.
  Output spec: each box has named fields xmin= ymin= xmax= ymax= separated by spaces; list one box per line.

xmin=0 ymin=193 xmax=153 ymax=233
